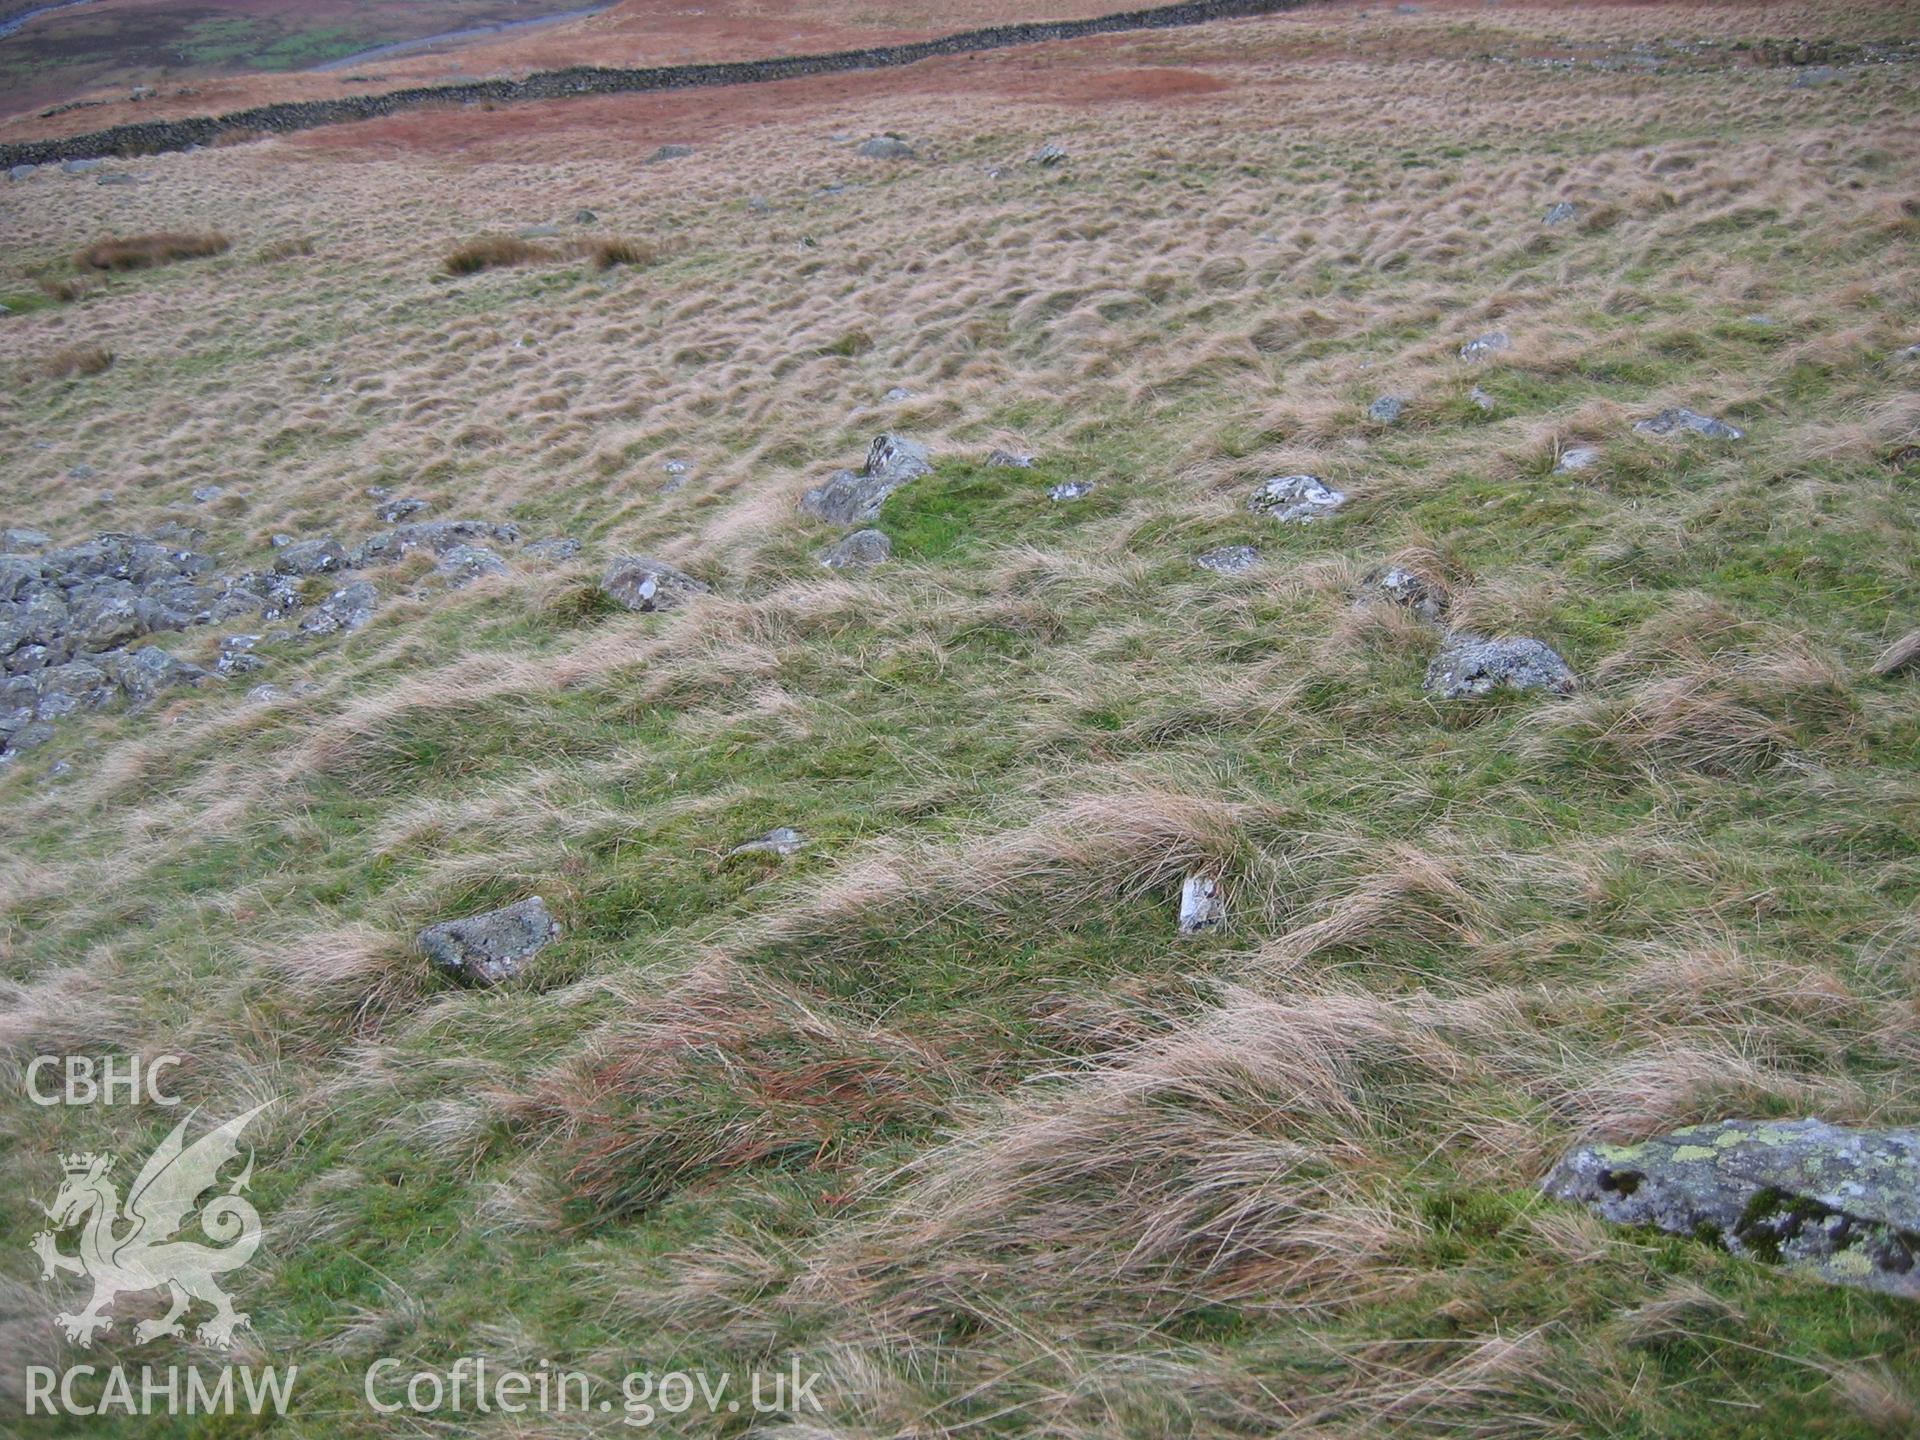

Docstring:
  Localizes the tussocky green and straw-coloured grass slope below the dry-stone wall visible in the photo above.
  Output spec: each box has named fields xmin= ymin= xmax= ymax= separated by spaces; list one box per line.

xmin=0 ymin=4 xmax=1920 ymax=1440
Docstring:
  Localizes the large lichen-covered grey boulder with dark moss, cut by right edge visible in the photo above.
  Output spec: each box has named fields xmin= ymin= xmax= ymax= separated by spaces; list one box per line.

xmin=1542 ymin=1119 xmax=1920 ymax=1300
